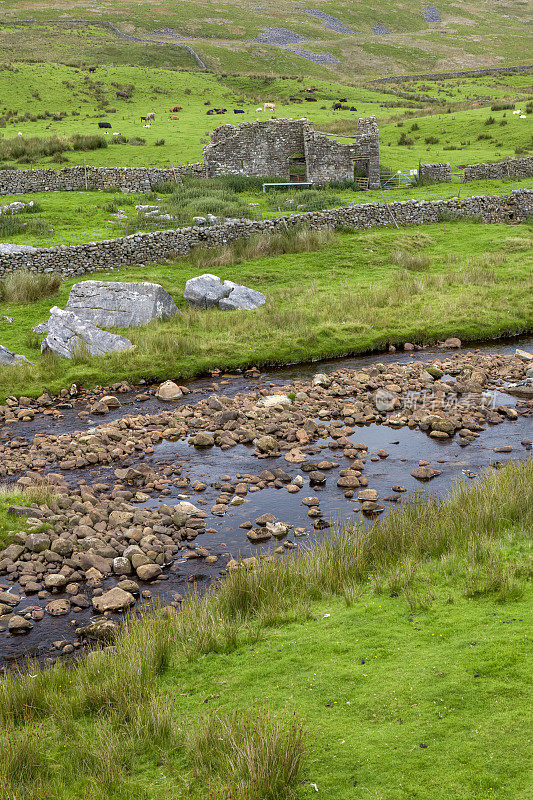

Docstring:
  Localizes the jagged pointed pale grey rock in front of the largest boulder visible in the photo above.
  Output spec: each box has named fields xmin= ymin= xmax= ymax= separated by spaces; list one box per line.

xmin=41 ymin=306 xmax=133 ymax=358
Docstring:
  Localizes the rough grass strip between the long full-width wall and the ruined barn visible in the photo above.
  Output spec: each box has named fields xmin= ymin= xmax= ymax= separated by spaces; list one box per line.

xmin=0 ymin=178 xmax=533 ymax=247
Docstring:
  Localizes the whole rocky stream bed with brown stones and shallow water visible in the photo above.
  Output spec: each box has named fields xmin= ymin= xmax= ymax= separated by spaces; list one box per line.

xmin=0 ymin=338 xmax=533 ymax=670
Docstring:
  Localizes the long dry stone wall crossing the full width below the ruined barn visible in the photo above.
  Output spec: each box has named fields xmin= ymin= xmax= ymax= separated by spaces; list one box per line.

xmin=0 ymin=189 xmax=533 ymax=276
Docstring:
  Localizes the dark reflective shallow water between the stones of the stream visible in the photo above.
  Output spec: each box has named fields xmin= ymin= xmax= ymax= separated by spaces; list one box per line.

xmin=0 ymin=337 xmax=533 ymax=667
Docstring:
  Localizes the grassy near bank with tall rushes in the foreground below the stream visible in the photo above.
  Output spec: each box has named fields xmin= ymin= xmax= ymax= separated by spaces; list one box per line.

xmin=0 ymin=460 xmax=533 ymax=800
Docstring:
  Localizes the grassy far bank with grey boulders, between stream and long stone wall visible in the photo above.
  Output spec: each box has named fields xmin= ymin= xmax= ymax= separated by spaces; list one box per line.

xmin=0 ymin=222 xmax=533 ymax=404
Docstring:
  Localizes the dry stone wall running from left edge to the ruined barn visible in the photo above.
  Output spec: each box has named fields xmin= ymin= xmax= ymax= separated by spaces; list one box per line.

xmin=0 ymin=162 xmax=205 ymax=195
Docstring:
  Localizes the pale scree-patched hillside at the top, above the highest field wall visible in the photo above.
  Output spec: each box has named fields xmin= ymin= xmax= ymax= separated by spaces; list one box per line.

xmin=0 ymin=0 xmax=530 ymax=79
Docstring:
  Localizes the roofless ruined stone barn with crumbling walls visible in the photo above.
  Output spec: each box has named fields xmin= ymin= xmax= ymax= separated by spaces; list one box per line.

xmin=203 ymin=117 xmax=380 ymax=188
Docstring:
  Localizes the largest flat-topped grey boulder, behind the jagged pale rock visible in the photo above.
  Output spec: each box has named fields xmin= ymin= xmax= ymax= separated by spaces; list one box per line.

xmin=67 ymin=281 xmax=179 ymax=328
